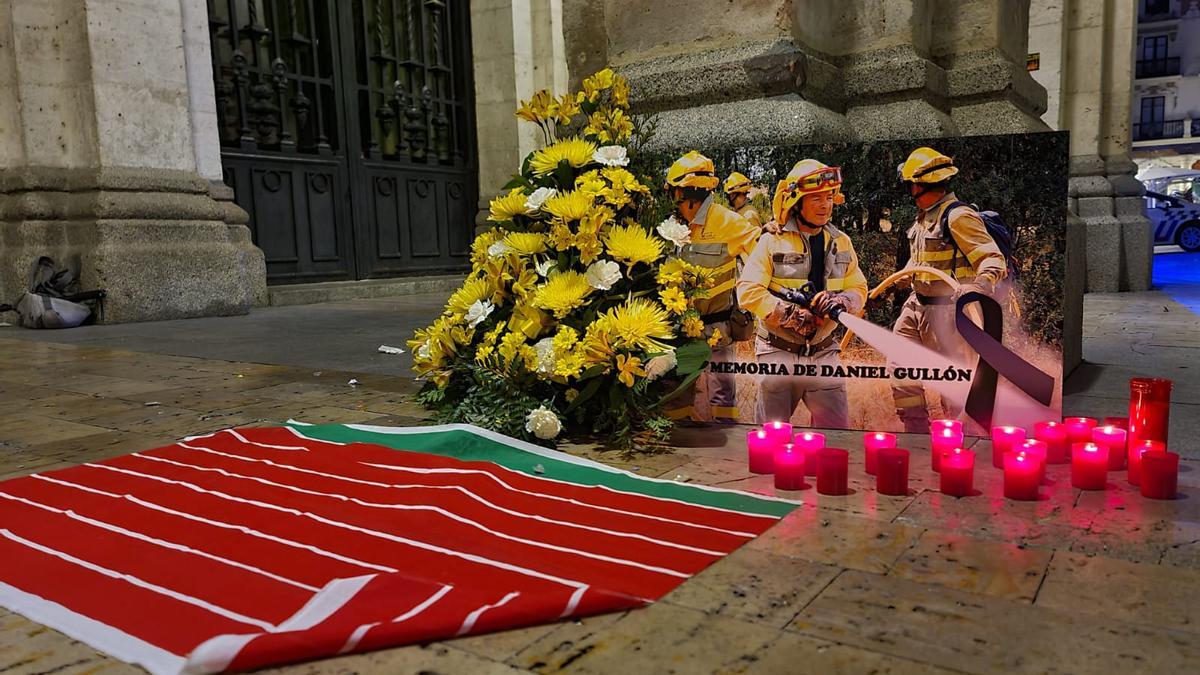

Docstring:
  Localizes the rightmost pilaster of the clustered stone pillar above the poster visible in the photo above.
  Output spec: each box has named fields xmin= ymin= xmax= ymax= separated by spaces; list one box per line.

xmin=931 ymin=0 xmax=1046 ymax=136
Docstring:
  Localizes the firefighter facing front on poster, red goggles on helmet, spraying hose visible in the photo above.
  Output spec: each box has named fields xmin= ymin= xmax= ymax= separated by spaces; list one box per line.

xmin=738 ymin=160 xmax=866 ymax=428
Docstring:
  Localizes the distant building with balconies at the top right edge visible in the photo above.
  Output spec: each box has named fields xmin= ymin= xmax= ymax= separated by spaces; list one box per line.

xmin=1132 ymin=0 xmax=1200 ymax=168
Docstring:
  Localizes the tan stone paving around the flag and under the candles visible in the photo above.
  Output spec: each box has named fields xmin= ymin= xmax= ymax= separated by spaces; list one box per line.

xmin=0 ymin=266 xmax=1200 ymax=675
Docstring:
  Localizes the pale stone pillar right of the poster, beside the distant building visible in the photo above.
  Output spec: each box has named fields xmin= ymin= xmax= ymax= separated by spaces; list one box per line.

xmin=1062 ymin=0 xmax=1153 ymax=292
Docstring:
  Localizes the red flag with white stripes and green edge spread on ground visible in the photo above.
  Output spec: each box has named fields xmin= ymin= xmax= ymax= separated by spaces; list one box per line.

xmin=0 ymin=424 xmax=797 ymax=674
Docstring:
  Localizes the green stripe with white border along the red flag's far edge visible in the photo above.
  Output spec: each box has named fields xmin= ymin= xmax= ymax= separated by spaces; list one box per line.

xmin=290 ymin=424 xmax=799 ymax=518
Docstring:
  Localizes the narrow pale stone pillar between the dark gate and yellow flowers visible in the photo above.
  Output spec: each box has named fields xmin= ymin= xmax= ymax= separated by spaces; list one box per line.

xmin=470 ymin=0 xmax=568 ymax=225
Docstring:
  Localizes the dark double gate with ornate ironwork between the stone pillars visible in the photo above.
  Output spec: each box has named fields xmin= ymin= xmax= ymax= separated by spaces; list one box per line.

xmin=209 ymin=0 xmax=478 ymax=282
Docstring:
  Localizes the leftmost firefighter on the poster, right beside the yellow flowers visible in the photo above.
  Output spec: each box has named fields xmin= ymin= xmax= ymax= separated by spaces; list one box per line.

xmin=664 ymin=150 xmax=761 ymax=423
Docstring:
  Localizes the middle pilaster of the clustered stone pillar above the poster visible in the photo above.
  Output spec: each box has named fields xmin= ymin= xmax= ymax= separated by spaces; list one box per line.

xmin=792 ymin=0 xmax=958 ymax=141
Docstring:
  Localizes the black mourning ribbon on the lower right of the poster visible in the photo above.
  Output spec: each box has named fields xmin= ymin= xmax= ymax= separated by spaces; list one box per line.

xmin=954 ymin=292 xmax=1054 ymax=429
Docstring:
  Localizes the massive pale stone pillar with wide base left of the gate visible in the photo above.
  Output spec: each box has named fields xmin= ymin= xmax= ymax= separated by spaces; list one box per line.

xmin=0 ymin=0 xmax=265 ymax=323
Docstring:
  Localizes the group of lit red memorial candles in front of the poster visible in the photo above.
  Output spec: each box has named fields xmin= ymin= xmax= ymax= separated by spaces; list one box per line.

xmin=746 ymin=378 xmax=1180 ymax=501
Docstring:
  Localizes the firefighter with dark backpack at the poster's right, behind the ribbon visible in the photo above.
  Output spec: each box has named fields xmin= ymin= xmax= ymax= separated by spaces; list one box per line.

xmin=892 ymin=148 xmax=1008 ymax=432
